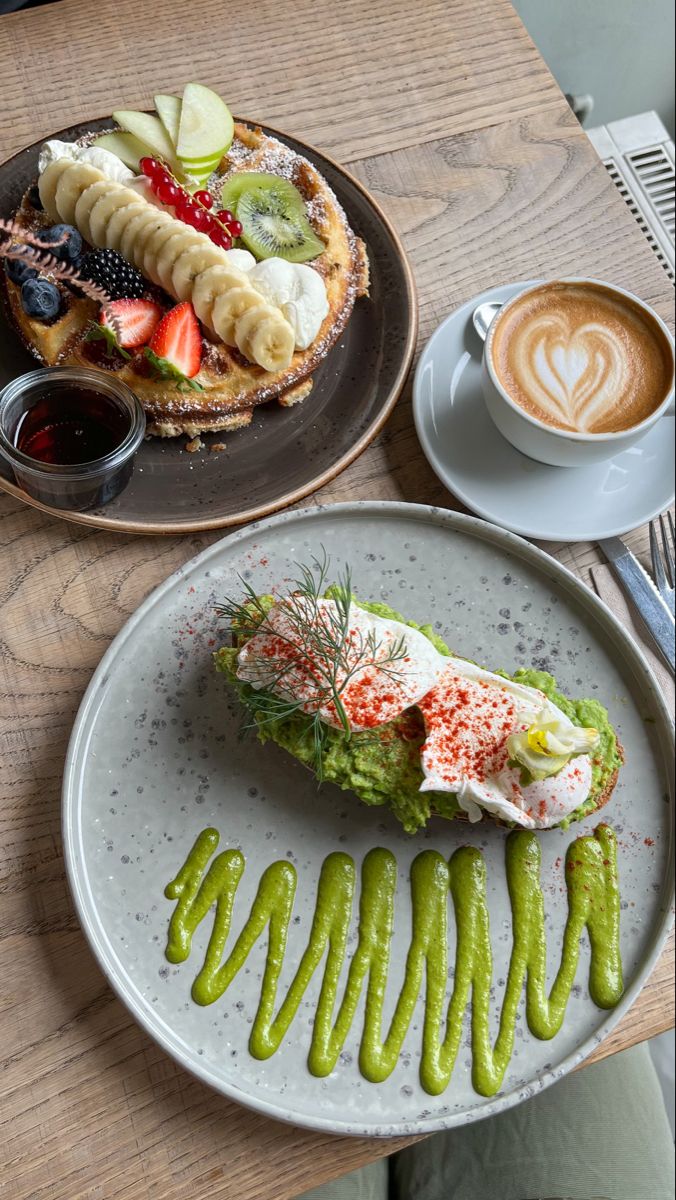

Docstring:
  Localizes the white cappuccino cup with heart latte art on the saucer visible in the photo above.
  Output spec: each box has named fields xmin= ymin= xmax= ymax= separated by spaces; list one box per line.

xmin=481 ymin=278 xmax=674 ymax=467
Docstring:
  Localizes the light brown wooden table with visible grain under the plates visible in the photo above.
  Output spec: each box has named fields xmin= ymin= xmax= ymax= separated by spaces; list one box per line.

xmin=0 ymin=0 xmax=674 ymax=1200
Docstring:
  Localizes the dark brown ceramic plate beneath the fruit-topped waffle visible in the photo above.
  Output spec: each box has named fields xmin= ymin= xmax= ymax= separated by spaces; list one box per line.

xmin=0 ymin=118 xmax=418 ymax=534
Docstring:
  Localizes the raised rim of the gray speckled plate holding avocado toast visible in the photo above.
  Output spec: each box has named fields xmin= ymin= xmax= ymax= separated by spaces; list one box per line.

xmin=61 ymin=500 xmax=676 ymax=1138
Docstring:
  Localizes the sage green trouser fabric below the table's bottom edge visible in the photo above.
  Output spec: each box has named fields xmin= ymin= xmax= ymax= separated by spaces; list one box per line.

xmin=297 ymin=1043 xmax=675 ymax=1200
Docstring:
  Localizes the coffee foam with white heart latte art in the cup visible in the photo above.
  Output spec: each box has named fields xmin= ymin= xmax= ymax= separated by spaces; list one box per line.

xmin=492 ymin=283 xmax=674 ymax=433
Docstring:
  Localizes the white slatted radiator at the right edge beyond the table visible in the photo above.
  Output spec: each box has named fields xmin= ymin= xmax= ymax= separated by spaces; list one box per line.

xmin=586 ymin=113 xmax=676 ymax=281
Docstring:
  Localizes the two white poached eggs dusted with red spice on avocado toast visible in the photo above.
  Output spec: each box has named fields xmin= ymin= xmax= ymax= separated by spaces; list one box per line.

xmin=237 ymin=595 xmax=598 ymax=829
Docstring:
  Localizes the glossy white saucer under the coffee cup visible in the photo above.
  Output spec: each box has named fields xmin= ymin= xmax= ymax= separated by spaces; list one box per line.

xmin=413 ymin=281 xmax=675 ymax=541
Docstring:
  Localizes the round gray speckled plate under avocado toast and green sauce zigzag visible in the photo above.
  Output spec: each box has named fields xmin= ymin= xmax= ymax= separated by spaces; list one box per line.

xmin=64 ymin=503 xmax=674 ymax=1136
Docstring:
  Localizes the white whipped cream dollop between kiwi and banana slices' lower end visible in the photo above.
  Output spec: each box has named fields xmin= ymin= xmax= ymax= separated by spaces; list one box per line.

xmin=249 ymin=258 xmax=329 ymax=350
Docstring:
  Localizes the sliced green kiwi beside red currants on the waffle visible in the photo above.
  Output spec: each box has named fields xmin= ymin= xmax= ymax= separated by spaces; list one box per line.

xmin=221 ymin=172 xmax=327 ymax=263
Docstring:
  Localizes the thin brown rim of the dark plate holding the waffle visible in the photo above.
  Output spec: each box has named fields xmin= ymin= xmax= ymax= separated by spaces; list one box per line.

xmin=0 ymin=114 xmax=419 ymax=536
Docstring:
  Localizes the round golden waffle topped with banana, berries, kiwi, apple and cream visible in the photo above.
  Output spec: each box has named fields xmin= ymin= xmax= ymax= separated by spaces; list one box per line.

xmin=5 ymin=84 xmax=369 ymax=438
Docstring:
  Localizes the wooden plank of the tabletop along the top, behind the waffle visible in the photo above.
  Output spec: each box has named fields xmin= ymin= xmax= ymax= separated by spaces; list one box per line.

xmin=0 ymin=0 xmax=562 ymax=162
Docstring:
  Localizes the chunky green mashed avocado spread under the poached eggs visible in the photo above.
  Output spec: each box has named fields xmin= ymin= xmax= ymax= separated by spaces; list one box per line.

xmin=215 ymin=590 xmax=622 ymax=833
